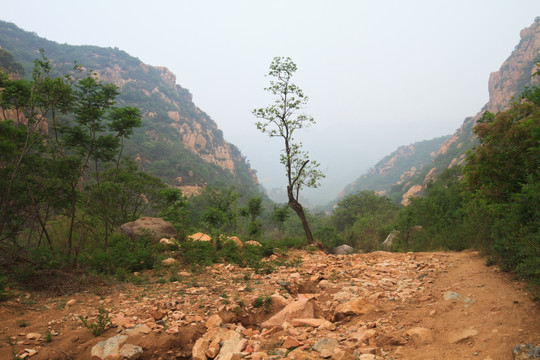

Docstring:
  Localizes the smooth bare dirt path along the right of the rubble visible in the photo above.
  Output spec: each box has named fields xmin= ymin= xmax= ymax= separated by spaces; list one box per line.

xmin=386 ymin=252 xmax=540 ymax=360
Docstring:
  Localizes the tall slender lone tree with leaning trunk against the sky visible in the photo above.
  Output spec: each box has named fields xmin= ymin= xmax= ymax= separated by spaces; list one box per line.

xmin=253 ymin=57 xmax=324 ymax=244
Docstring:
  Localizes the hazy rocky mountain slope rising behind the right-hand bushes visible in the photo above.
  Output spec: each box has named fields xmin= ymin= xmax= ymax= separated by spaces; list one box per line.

xmin=336 ymin=17 xmax=540 ymax=205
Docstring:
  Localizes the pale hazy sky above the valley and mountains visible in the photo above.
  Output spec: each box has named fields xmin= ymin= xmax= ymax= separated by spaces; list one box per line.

xmin=0 ymin=0 xmax=540 ymax=205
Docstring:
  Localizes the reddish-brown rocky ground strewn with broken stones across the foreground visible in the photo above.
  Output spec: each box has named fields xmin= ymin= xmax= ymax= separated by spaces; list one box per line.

xmin=0 ymin=251 xmax=540 ymax=360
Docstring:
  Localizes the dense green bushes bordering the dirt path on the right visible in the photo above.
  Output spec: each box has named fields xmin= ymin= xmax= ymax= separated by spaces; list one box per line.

xmin=388 ymin=88 xmax=540 ymax=288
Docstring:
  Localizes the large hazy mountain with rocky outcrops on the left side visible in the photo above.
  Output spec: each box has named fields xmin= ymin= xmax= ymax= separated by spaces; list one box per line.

xmin=0 ymin=21 xmax=262 ymax=200
